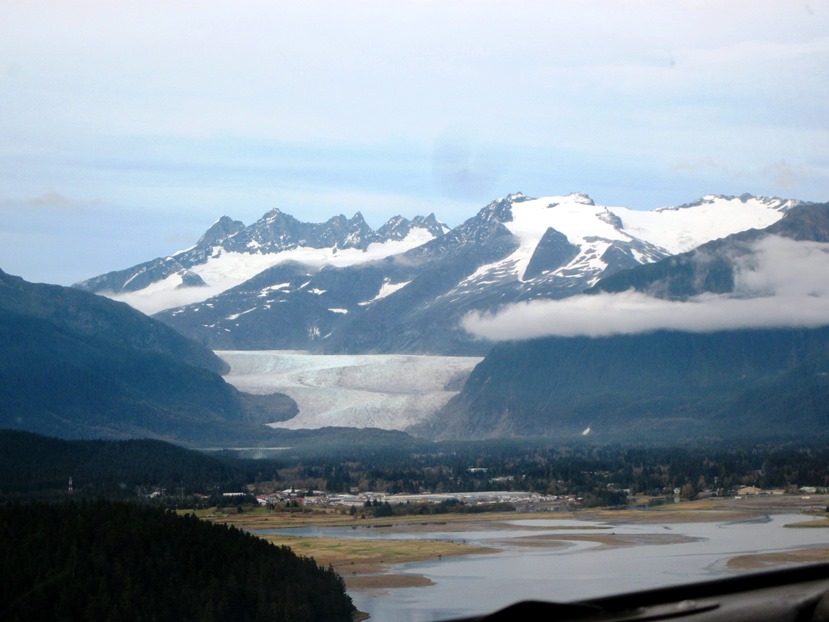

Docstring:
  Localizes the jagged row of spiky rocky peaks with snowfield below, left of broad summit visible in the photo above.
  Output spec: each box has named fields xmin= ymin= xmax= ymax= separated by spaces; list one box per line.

xmin=87 ymin=208 xmax=444 ymax=313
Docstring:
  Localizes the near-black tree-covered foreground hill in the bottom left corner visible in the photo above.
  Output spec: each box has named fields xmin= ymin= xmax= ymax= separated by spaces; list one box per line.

xmin=0 ymin=500 xmax=354 ymax=622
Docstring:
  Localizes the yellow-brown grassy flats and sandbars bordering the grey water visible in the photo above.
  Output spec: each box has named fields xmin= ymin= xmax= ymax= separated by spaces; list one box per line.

xmin=205 ymin=495 xmax=829 ymax=592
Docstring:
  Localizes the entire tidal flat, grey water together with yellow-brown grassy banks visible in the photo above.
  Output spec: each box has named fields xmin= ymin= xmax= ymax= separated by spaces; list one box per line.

xmin=209 ymin=495 xmax=829 ymax=622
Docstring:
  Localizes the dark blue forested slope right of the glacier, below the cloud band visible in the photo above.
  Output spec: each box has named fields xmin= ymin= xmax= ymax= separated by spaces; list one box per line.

xmin=429 ymin=328 xmax=829 ymax=442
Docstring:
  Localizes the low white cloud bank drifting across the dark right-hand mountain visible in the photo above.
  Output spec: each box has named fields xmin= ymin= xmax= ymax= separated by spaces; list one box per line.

xmin=461 ymin=236 xmax=829 ymax=341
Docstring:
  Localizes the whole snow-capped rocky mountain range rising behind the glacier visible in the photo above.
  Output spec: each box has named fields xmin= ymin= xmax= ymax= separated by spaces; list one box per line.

xmin=75 ymin=193 xmax=798 ymax=355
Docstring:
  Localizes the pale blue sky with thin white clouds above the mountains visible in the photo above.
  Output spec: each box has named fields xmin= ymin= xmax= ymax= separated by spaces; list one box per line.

xmin=0 ymin=0 xmax=829 ymax=285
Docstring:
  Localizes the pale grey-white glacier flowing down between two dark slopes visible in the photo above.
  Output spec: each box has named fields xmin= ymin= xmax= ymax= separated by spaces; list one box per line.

xmin=216 ymin=350 xmax=481 ymax=430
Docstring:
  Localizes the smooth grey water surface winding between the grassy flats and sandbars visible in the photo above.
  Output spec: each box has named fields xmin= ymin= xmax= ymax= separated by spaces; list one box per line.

xmin=262 ymin=514 xmax=829 ymax=622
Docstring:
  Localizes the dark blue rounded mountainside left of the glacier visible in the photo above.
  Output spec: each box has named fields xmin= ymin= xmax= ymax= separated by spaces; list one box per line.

xmin=0 ymin=272 xmax=296 ymax=444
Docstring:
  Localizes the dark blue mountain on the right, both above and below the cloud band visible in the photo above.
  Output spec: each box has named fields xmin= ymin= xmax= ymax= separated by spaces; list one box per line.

xmin=434 ymin=204 xmax=829 ymax=441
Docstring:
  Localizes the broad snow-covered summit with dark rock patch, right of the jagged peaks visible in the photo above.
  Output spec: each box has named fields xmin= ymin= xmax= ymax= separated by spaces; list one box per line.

xmin=456 ymin=193 xmax=793 ymax=291
